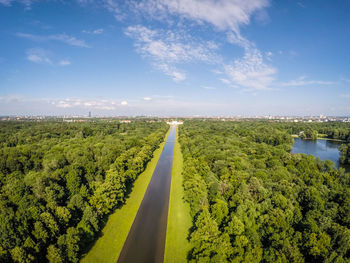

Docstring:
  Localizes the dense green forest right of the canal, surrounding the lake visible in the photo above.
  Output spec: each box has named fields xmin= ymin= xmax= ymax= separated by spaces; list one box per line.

xmin=179 ymin=120 xmax=350 ymax=262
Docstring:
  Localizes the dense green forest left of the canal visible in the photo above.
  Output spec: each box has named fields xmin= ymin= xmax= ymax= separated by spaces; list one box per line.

xmin=0 ymin=121 xmax=168 ymax=263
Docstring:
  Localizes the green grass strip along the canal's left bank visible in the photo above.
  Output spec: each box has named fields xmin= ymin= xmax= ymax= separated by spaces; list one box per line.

xmin=80 ymin=132 xmax=169 ymax=263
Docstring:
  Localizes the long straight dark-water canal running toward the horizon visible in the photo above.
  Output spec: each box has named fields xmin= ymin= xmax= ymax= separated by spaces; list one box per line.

xmin=118 ymin=127 xmax=176 ymax=263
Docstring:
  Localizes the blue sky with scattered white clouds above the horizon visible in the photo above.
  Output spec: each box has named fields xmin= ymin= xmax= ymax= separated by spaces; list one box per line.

xmin=0 ymin=0 xmax=350 ymax=116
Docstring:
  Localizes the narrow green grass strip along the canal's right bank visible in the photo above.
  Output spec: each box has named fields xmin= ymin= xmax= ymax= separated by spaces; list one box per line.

xmin=164 ymin=127 xmax=192 ymax=263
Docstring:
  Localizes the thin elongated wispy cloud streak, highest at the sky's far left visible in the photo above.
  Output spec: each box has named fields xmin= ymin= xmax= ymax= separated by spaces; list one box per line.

xmin=16 ymin=33 xmax=89 ymax=48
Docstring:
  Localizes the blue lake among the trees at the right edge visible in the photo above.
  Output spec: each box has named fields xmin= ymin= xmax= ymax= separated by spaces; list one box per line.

xmin=292 ymin=138 xmax=350 ymax=171
